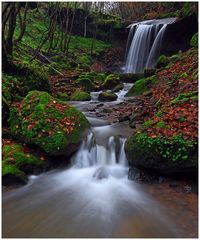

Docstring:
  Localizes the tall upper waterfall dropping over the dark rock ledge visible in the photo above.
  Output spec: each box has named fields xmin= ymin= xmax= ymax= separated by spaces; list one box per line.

xmin=125 ymin=18 xmax=176 ymax=73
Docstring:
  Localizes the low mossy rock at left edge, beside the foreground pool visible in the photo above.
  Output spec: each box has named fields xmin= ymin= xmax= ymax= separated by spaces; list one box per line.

xmin=2 ymin=141 xmax=44 ymax=185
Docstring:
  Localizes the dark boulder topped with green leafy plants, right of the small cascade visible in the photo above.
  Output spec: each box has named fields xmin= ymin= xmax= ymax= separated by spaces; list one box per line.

xmin=125 ymin=133 xmax=198 ymax=175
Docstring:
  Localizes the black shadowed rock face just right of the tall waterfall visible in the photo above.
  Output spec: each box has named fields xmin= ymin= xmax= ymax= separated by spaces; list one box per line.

xmin=161 ymin=14 xmax=198 ymax=55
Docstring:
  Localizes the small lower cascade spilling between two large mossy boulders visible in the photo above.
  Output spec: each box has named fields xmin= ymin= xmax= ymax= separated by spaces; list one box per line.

xmin=72 ymin=133 xmax=127 ymax=168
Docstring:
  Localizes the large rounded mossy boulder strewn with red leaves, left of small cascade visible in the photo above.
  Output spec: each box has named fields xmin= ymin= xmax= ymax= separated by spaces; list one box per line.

xmin=9 ymin=91 xmax=89 ymax=156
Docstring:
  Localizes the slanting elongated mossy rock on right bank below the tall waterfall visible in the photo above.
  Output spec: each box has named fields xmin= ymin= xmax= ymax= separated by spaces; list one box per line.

xmin=126 ymin=75 xmax=157 ymax=97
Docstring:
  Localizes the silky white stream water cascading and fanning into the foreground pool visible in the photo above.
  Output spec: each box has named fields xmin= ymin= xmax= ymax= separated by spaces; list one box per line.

xmin=2 ymin=83 xmax=198 ymax=238
